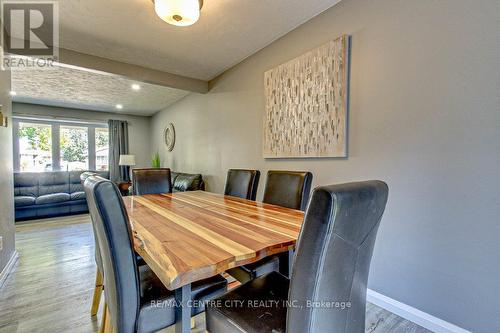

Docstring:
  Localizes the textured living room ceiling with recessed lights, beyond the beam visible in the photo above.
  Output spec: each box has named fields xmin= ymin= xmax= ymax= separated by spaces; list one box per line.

xmin=12 ymin=67 xmax=188 ymax=116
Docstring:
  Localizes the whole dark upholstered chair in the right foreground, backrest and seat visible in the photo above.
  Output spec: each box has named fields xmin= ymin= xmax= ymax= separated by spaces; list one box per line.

xmin=206 ymin=181 xmax=388 ymax=333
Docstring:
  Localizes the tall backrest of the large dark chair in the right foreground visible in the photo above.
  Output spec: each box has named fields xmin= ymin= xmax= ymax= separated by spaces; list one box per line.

xmin=287 ymin=181 xmax=388 ymax=333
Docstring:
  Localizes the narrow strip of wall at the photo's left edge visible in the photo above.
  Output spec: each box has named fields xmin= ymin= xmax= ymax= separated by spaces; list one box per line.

xmin=0 ymin=70 xmax=15 ymax=272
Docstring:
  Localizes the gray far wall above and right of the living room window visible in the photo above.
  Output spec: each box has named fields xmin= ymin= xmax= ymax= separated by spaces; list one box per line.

xmin=12 ymin=103 xmax=151 ymax=167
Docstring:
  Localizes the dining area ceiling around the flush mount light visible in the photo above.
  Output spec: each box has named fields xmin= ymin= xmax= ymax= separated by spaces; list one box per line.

xmin=59 ymin=0 xmax=340 ymax=80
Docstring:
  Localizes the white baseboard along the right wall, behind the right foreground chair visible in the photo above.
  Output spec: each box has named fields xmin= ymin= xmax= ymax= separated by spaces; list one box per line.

xmin=366 ymin=289 xmax=472 ymax=333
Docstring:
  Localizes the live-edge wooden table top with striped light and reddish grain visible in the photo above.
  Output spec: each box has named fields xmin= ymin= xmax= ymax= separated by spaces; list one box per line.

xmin=123 ymin=191 xmax=304 ymax=290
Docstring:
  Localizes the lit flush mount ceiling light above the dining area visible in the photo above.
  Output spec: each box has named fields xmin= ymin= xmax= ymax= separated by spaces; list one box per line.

xmin=153 ymin=0 xmax=203 ymax=27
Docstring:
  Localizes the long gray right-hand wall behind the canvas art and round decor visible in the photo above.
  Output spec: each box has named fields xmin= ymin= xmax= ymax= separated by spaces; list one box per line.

xmin=151 ymin=0 xmax=500 ymax=332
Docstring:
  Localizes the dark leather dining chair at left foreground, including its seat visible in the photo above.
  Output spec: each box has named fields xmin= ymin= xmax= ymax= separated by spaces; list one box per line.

xmin=84 ymin=176 xmax=227 ymax=333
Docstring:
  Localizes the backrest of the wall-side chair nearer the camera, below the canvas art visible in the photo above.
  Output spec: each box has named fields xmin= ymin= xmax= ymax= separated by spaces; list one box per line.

xmin=263 ymin=170 xmax=312 ymax=210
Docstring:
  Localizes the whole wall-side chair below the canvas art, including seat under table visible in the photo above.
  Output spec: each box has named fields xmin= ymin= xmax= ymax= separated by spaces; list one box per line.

xmin=227 ymin=170 xmax=313 ymax=283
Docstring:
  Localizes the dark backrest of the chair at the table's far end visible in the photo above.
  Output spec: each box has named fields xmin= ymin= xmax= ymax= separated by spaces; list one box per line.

xmin=132 ymin=168 xmax=172 ymax=195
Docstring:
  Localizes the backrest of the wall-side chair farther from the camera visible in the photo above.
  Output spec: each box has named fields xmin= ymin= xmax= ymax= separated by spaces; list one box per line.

xmin=224 ymin=169 xmax=260 ymax=200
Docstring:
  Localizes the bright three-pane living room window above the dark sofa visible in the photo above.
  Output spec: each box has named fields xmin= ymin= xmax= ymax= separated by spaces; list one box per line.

xmin=14 ymin=119 xmax=109 ymax=172
